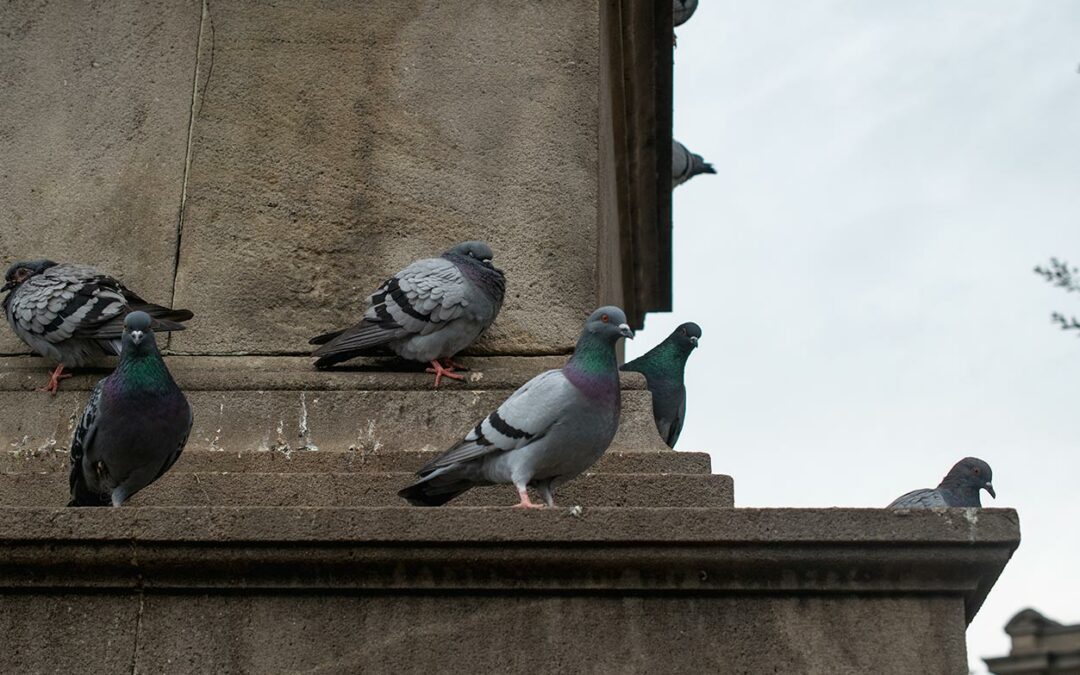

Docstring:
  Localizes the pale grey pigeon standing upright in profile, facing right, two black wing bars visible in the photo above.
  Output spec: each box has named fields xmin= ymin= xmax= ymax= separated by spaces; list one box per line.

xmin=397 ymin=307 xmax=634 ymax=509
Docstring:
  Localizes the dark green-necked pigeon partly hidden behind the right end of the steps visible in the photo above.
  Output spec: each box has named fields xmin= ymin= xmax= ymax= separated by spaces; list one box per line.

xmin=621 ymin=323 xmax=701 ymax=448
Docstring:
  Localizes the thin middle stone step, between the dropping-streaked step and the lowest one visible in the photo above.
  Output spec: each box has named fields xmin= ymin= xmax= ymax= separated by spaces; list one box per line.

xmin=0 ymin=448 xmax=710 ymax=474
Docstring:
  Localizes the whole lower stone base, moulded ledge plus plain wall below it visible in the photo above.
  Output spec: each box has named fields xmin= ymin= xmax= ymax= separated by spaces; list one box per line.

xmin=0 ymin=507 xmax=1020 ymax=674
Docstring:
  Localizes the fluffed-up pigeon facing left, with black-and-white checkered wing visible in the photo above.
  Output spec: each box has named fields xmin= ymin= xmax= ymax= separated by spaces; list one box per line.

xmin=0 ymin=260 xmax=192 ymax=394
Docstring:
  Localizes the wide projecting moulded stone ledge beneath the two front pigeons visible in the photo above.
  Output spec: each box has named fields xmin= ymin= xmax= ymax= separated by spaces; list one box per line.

xmin=0 ymin=508 xmax=1020 ymax=621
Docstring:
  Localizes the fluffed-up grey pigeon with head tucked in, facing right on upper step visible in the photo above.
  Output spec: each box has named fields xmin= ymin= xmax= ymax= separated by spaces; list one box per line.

xmin=311 ymin=242 xmax=507 ymax=387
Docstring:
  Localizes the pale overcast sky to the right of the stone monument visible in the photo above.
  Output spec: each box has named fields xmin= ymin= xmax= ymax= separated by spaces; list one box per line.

xmin=627 ymin=0 xmax=1080 ymax=673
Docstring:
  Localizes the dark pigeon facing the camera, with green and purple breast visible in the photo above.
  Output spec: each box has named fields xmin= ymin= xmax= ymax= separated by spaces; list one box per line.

xmin=68 ymin=312 xmax=191 ymax=507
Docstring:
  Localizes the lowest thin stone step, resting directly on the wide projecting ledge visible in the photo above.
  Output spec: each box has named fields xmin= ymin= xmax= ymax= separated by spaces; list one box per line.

xmin=0 ymin=471 xmax=734 ymax=508
